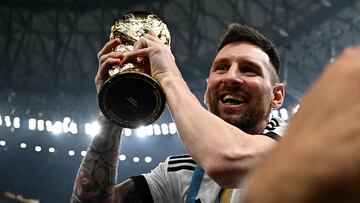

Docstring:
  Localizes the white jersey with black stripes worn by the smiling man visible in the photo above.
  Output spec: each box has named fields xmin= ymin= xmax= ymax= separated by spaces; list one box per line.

xmin=132 ymin=117 xmax=286 ymax=203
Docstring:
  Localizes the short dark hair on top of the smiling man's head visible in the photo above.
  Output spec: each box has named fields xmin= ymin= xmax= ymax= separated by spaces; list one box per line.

xmin=217 ymin=23 xmax=281 ymax=80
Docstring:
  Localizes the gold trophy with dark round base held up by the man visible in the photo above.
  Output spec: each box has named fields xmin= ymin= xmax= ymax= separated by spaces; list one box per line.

xmin=98 ymin=12 xmax=171 ymax=128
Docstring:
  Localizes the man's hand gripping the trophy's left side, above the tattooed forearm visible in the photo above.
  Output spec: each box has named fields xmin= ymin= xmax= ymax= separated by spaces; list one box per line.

xmin=95 ymin=38 xmax=125 ymax=93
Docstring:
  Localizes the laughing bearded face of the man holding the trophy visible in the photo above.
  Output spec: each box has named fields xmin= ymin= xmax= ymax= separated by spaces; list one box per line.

xmin=205 ymin=42 xmax=273 ymax=134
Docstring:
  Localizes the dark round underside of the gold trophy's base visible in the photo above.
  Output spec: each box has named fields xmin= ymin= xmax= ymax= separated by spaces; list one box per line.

xmin=98 ymin=71 xmax=166 ymax=128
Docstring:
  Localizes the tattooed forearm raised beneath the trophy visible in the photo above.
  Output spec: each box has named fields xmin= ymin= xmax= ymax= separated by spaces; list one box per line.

xmin=71 ymin=116 xmax=121 ymax=203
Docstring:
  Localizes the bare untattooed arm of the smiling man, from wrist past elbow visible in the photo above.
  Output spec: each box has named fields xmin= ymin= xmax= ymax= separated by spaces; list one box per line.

xmin=163 ymin=78 xmax=273 ymax=187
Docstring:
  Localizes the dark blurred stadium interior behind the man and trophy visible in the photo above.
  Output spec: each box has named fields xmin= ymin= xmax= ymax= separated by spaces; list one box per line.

xmin=0 ymin=0 xmax=360 ymax=203
